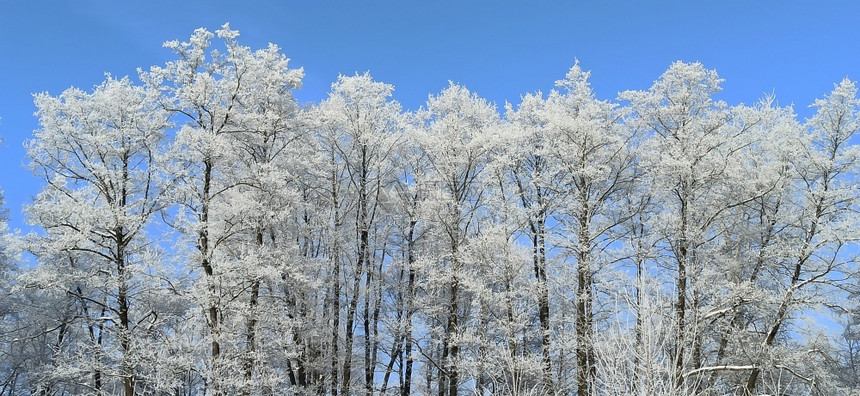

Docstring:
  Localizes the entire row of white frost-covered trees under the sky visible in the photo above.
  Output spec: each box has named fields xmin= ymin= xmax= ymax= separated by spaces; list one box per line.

xmin=0 ymin=25 xmax=860 ymax=396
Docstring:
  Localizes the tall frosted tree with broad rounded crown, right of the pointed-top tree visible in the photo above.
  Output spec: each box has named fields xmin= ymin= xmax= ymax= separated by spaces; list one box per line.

xmin=621 ymin=62 xmax=760 ymax=391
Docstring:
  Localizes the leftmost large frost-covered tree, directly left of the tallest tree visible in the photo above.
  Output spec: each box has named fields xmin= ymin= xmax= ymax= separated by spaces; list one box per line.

xmin=27 ymin=77 xmax=170 ymax=395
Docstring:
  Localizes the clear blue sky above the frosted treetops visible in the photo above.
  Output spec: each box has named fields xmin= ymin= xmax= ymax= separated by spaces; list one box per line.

xmin=0 ymin=0 xmax=860 ymax=232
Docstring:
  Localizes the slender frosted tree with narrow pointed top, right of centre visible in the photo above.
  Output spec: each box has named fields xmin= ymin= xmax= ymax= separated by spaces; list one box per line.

xmin=545 ymin=64 xmax=641 ymax=395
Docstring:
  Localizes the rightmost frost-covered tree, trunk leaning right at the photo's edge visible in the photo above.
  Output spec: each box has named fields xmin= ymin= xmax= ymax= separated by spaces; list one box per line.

xmin=745 ymin=79 xmax=860 ymax=393
